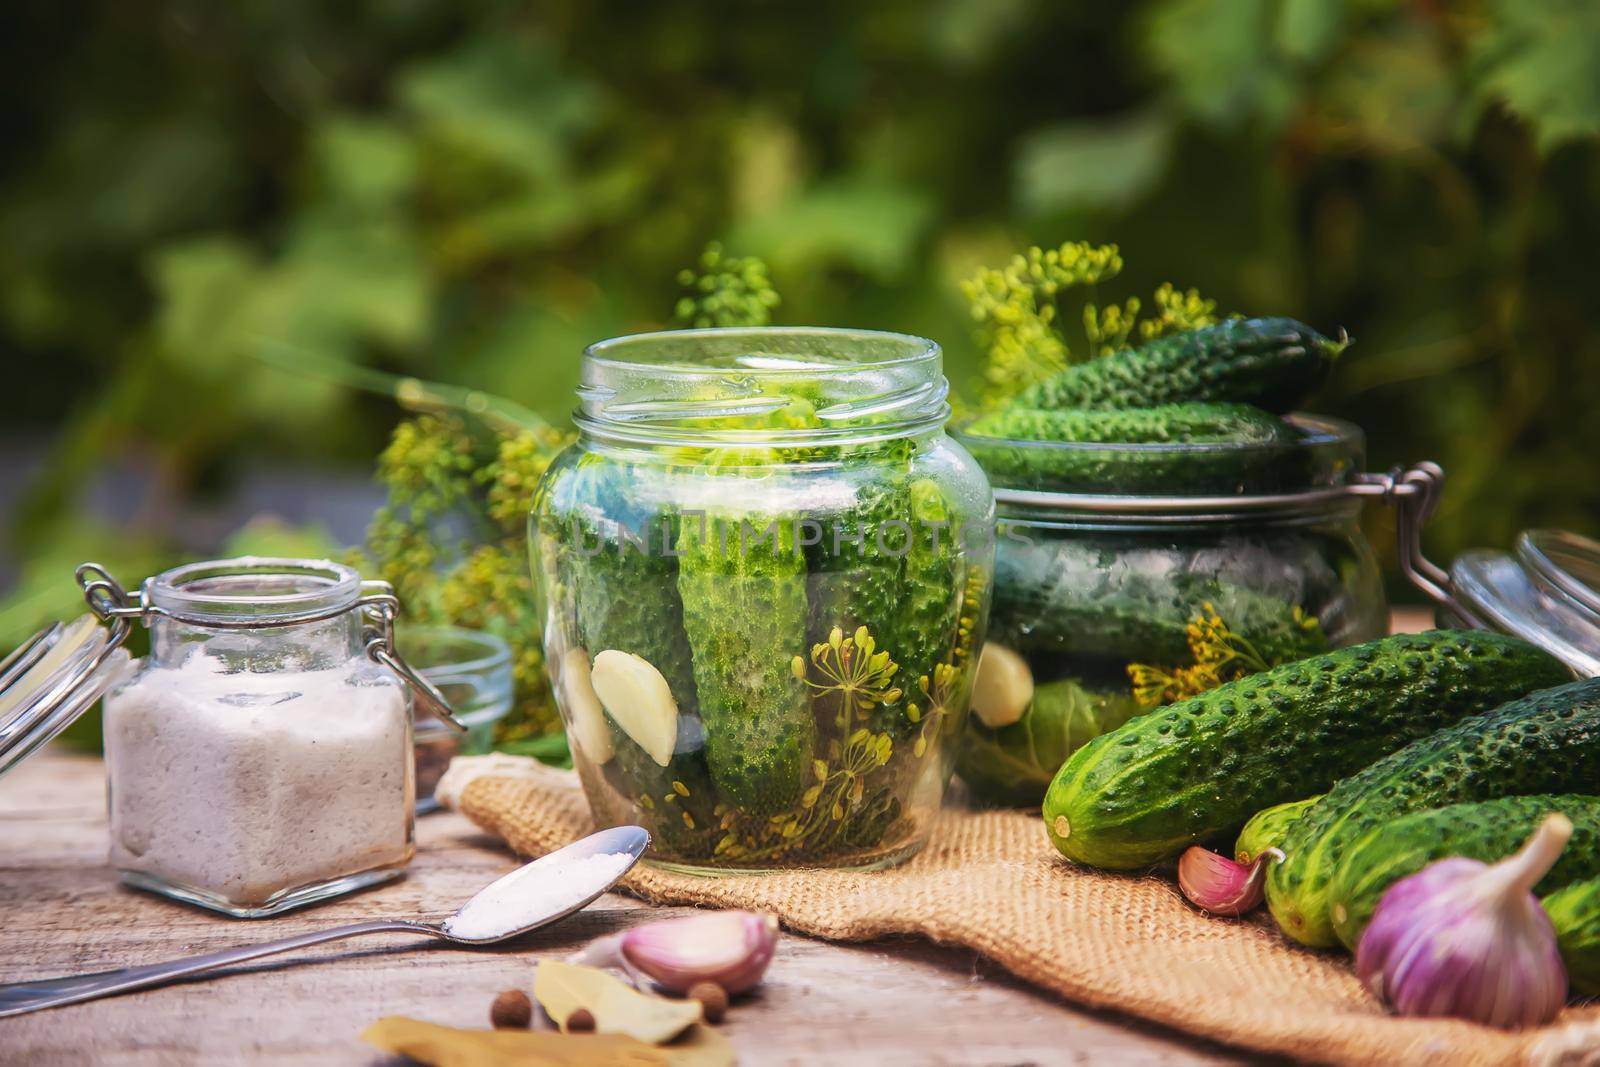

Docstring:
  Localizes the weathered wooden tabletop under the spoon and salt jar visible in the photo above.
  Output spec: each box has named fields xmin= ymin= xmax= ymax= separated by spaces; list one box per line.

xmin=0 ymin=750 xmax=1245 ymax=1067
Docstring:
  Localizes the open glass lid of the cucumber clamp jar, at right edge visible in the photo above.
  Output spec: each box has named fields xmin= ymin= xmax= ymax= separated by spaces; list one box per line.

xmin=1445 ymin=530 xmax=1600 ymax=677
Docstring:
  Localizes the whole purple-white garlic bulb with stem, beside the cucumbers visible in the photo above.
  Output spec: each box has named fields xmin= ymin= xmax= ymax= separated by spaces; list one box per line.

xmin=1355 ymin=814 xmax=1573 ymax=1029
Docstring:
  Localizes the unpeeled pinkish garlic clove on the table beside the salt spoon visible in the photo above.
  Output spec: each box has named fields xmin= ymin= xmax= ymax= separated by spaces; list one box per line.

xmin=621 ymin=912 xmax=778 ymax=995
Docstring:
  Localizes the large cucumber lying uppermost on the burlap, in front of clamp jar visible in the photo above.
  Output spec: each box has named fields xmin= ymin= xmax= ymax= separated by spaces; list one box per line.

xmin=1045 ymin=630 xmax=1566 ymax=870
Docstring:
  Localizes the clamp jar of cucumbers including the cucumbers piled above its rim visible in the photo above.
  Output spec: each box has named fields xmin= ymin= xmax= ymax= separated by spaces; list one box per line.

xmin=955 ymin=318 xmax=1387 ymax=805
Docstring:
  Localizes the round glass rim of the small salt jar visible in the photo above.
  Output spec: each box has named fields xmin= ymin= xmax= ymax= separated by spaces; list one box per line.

xmin=146 ymin=555 xmax=362 ymax=625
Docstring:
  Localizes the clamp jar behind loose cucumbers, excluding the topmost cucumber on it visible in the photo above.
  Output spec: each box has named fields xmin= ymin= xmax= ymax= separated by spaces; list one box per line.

xmin=955 ymin=416 xmax=1394 ymax=803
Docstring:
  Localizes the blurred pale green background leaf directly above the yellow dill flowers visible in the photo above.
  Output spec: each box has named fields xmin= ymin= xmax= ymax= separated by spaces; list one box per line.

xmin=1018 ymin=110 xmax=1173 ymax=211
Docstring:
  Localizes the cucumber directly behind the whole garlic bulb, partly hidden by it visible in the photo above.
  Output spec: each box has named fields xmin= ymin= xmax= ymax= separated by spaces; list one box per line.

xmin=1328 ymin=793 xmax=1600 ymax=950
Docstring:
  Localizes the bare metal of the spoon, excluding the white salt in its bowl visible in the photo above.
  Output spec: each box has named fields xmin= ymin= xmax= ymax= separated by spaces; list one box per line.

xmin=0 ymin=825 xmax=650 ymax=1017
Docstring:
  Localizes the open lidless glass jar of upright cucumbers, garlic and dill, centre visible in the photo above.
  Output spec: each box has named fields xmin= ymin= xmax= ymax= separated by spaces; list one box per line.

xmin=531 ymin=328 xmax=994 ymax=870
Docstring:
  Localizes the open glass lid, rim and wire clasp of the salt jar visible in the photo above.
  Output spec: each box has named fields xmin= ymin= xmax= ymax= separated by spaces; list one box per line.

xmin=0 ymin=557 xmax=466 ymax=774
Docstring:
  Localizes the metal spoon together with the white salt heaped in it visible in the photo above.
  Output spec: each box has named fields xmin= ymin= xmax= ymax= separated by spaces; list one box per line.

xmin=0 ymin=825 xmax=650 ymax=1019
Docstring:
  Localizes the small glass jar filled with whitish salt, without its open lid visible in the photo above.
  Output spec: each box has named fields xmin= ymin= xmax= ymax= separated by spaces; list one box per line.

xmin=91 ymin=558 xmax=414 ymax=918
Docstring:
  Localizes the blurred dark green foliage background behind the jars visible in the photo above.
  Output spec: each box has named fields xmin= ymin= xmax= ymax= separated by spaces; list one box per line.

xmin=0 ymin=0 xmax=1600 ymax=640
